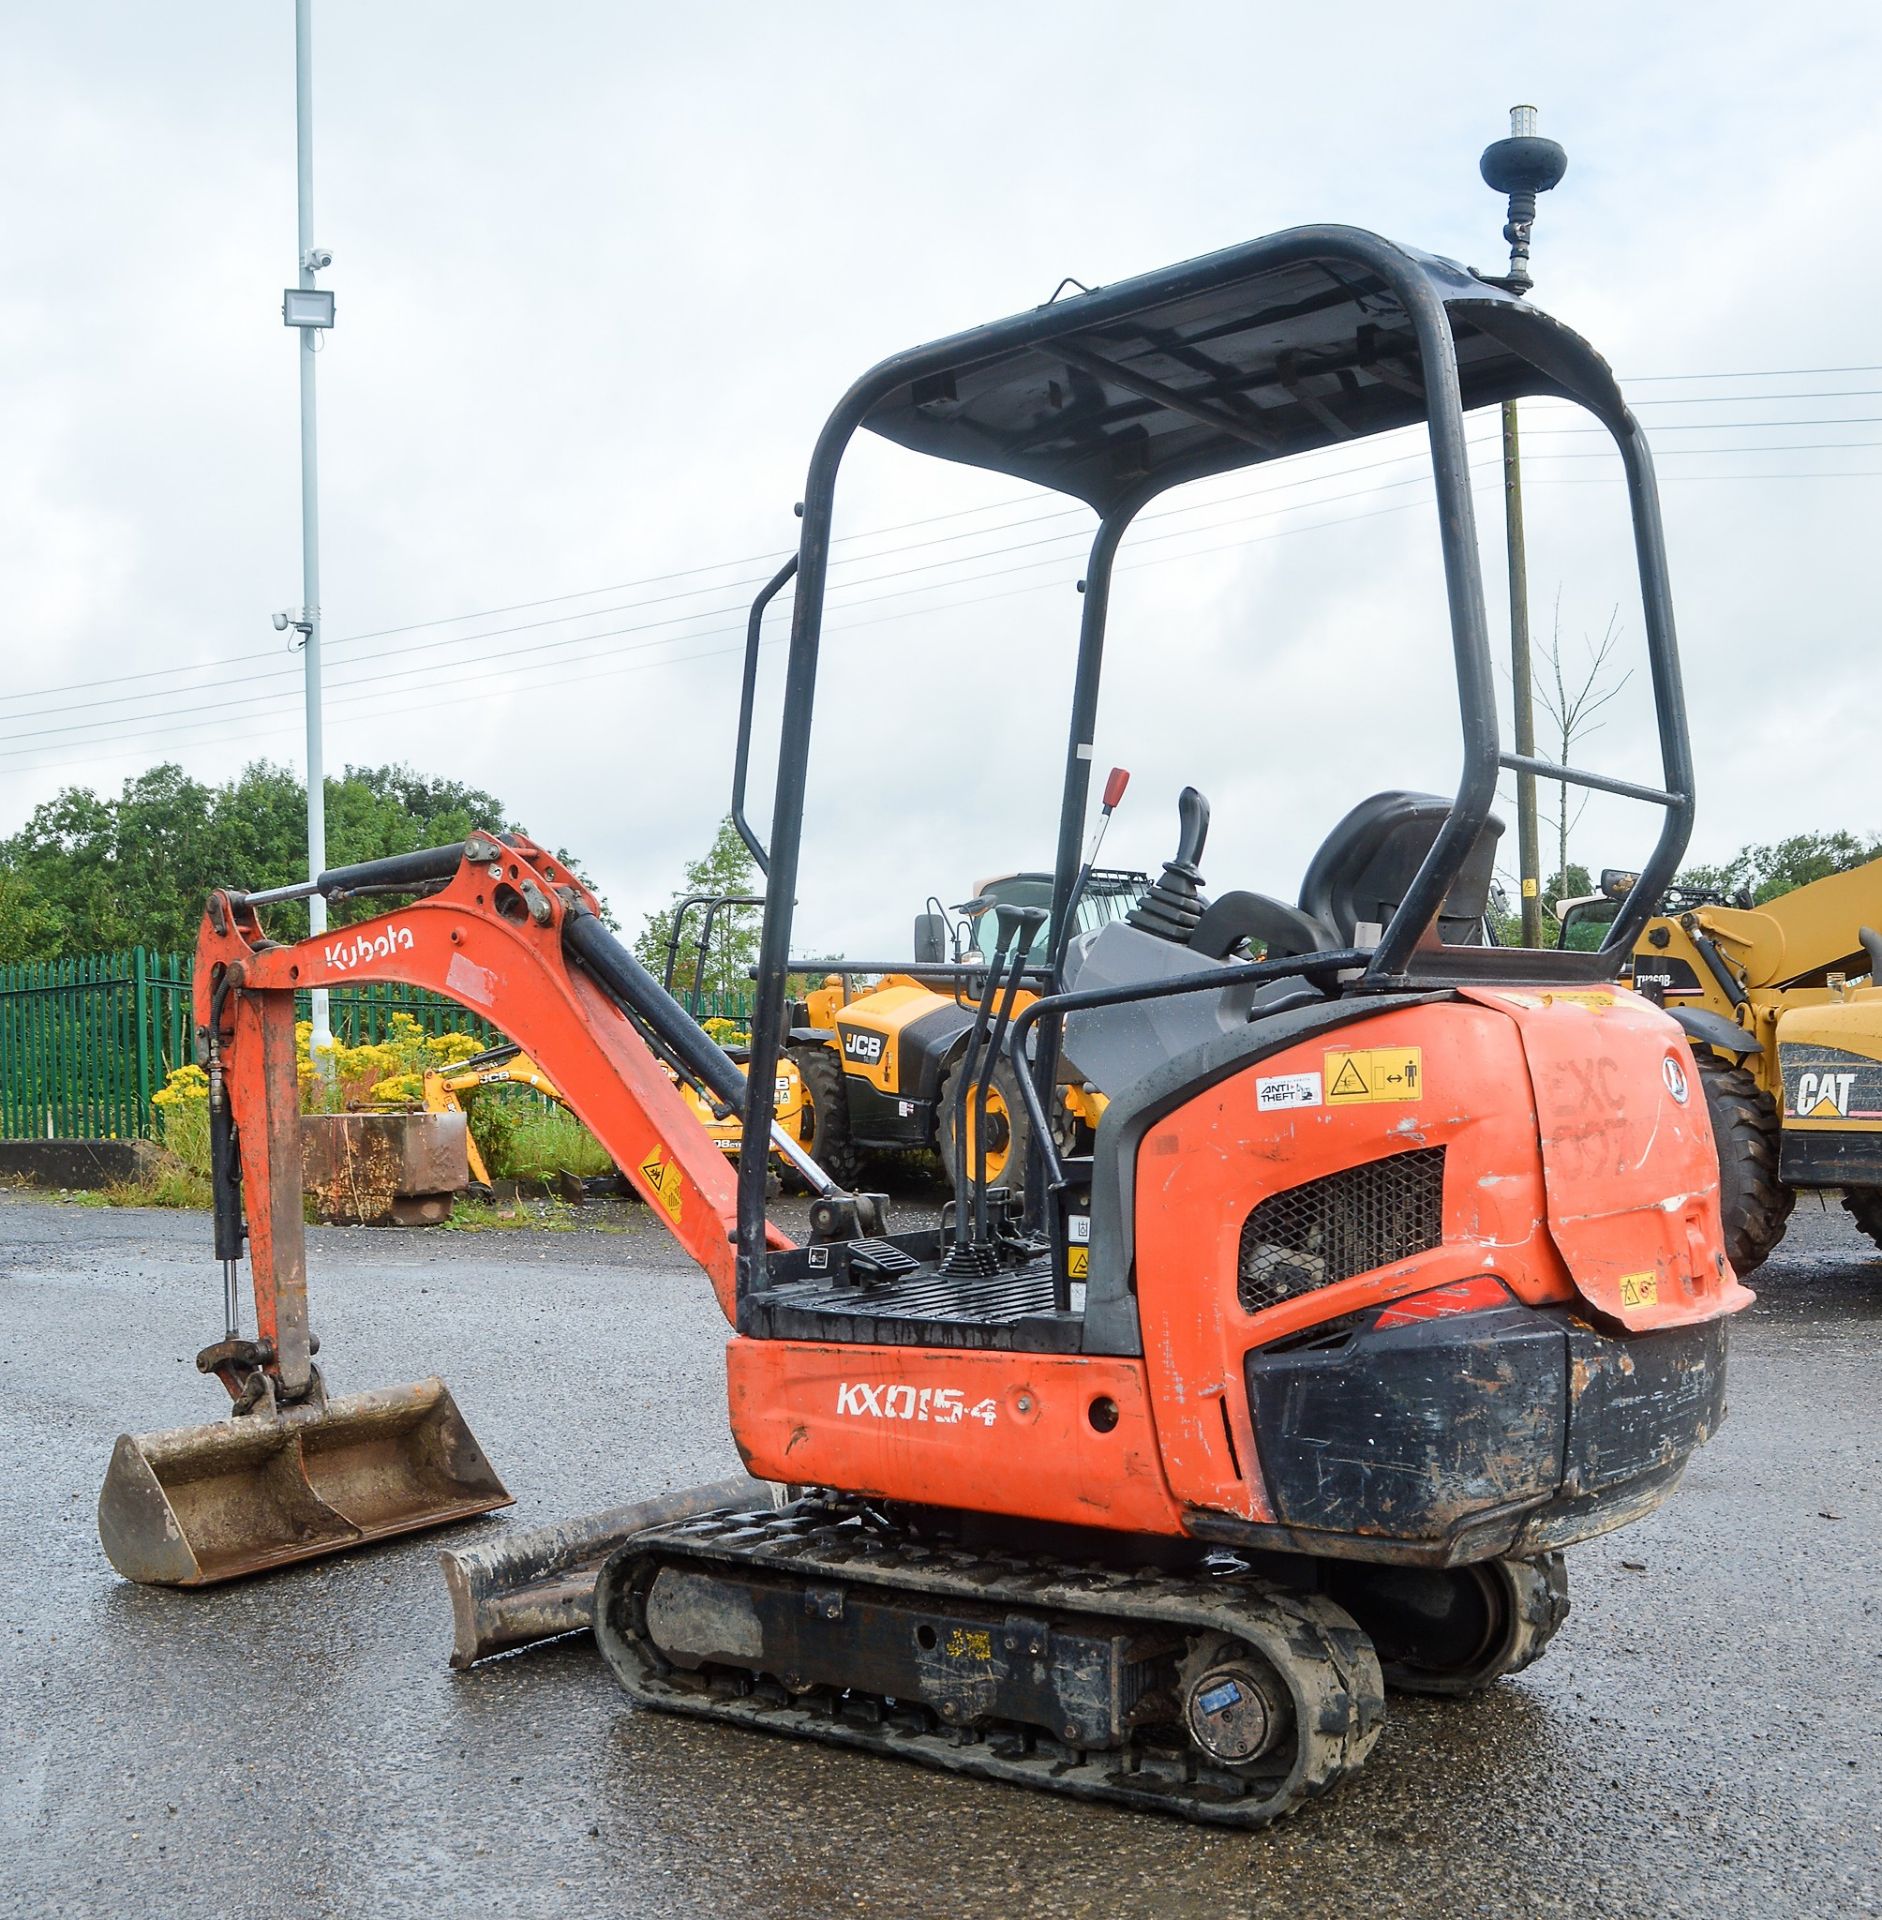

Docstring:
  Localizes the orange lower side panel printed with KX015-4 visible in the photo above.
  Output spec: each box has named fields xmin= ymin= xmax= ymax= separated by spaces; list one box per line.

xmin=726 ymin=1340 xmax=1183 ymax=1534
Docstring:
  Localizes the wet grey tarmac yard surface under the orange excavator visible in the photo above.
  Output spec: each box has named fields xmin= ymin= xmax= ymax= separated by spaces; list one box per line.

xmin=0 ymin=1192 xmax=1882 ymax=1920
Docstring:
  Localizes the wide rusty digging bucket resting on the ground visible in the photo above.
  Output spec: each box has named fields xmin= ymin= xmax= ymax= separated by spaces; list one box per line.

xmin=98 ymin=1379 xmax=511 ymax=1586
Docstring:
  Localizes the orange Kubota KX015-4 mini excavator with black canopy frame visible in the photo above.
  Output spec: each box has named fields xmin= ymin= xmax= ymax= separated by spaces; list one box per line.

xmin=102 ymin=227 xmax=1749 ymax=1826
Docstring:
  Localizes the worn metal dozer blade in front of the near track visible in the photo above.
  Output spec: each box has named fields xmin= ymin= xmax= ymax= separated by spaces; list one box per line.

xmin=438 ymin=1473 xmax=772 ymax=1668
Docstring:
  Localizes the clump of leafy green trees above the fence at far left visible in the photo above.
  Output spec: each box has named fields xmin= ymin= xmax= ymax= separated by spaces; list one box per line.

xmin=0 ymin=760 xmax=603 ymax=960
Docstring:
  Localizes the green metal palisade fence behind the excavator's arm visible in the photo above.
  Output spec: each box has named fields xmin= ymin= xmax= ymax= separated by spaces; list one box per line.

xmin=0 ymin=947 xmax=751 ymax=1140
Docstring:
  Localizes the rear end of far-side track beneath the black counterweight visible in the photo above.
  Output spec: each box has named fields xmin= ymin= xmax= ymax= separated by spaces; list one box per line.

xmin=1331 ymin=1553 xmax=1569 ymax=1695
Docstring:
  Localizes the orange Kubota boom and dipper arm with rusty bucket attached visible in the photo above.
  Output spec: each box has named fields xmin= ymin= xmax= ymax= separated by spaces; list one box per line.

xmin=98 ymin=833 xmax=806 ymax=1586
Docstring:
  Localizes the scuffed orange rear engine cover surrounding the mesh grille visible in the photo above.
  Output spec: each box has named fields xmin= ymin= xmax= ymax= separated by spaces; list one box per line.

xmin=1135 ymin=993 xmax=1751 ymax=1521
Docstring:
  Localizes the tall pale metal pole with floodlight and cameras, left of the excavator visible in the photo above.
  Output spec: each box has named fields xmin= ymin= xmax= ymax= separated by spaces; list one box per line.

xmin=275 ymin=0 xmax=334 ymax=1073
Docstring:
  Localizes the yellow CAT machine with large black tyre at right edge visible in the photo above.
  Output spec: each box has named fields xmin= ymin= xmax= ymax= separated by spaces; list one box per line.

xmin=1557 ymin=860 xmax=1882 ymax=1273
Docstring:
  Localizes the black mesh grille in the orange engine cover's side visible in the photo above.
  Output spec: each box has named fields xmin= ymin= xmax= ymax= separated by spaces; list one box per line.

xmin=1237 ymin=1146 xmax=1444 ymax=1313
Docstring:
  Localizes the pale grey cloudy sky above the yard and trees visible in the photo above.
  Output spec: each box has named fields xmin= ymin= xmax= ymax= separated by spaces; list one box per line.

xmin=0 ymin=0 xmax=1882 ymax=952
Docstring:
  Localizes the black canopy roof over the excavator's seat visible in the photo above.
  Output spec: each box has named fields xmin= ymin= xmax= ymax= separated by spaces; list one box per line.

xmin=862 ymin=227 xmax=1630 ymax=513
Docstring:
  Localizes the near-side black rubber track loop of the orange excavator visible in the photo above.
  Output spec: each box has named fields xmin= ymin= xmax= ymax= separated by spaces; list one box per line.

xmin=595 ymin=1501 xmax=1385 ymax=1828
